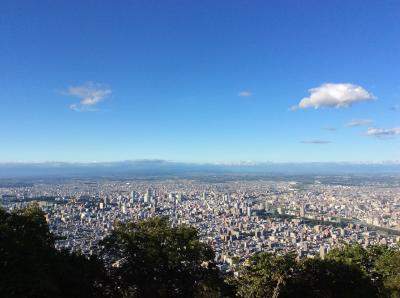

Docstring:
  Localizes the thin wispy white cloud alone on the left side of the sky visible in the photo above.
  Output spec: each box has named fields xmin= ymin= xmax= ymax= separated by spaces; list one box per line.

xmin=67 ymin=82 xmax=112 ymax=112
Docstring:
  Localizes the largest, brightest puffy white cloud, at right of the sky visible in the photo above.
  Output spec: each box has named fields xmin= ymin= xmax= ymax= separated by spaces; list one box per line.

xmin=298 ymin=83 xmax=376 ymax=109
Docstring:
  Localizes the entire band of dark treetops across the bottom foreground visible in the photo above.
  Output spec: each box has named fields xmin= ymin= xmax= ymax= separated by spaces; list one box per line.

xmin=0 ymin=203 xmax=400 ymax=298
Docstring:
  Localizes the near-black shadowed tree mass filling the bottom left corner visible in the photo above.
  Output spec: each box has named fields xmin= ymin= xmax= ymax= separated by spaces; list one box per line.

xmin=0 ymin=203 xmax=108 ymax=298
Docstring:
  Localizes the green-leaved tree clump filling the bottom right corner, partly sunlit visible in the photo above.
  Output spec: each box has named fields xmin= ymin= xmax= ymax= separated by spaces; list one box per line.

xmin=234 ymin=245 xmax=400 ymax=298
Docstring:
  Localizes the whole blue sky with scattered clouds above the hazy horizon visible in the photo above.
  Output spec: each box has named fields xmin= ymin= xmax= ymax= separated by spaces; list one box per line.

xmin=0 ymin=0 xmax=400 ymax=162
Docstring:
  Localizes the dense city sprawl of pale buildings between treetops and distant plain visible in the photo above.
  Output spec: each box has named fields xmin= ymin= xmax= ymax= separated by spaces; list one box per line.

xmin=0 ymin=179 xmax=400 ymax=271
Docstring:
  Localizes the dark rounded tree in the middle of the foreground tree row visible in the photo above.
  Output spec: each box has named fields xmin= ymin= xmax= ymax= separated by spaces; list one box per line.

xmin=103 ymin=217 xmax=230 ymax=297
